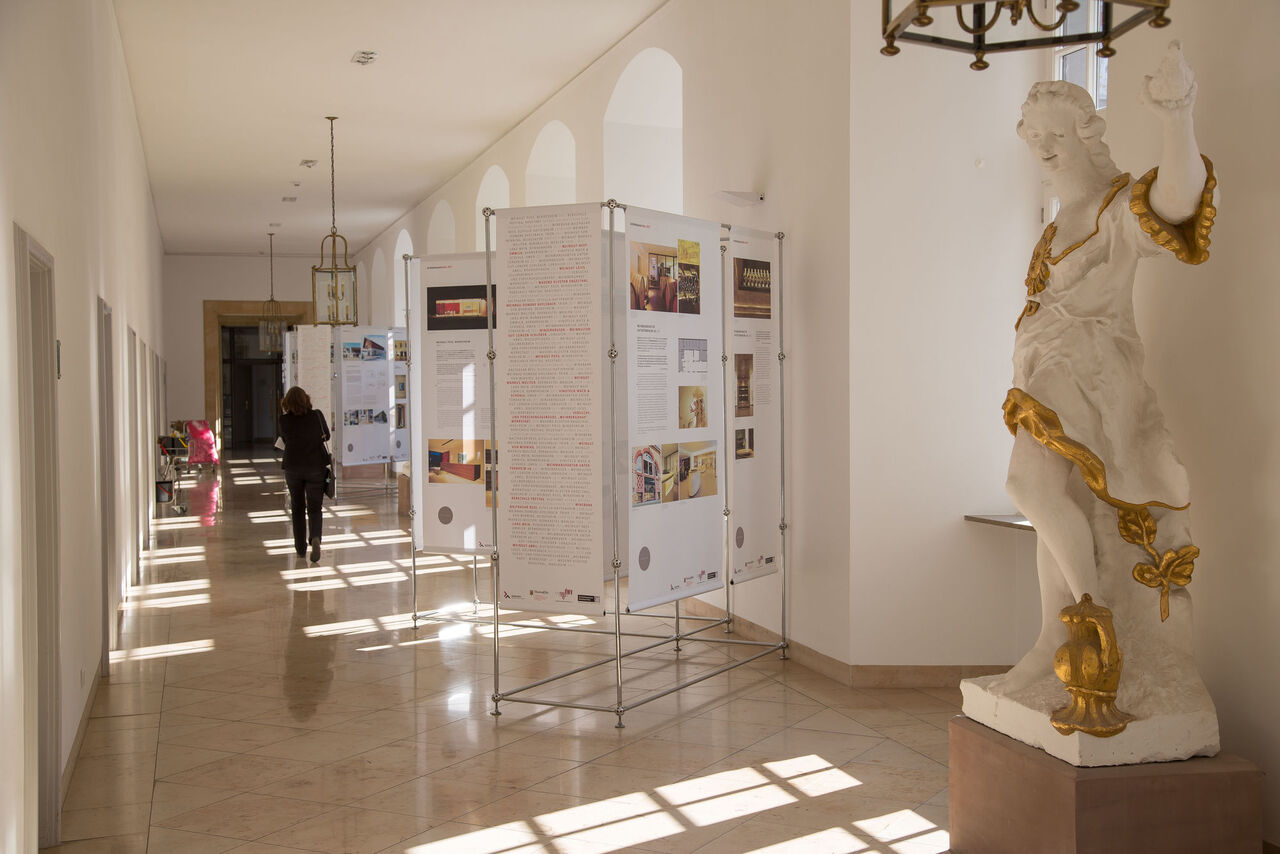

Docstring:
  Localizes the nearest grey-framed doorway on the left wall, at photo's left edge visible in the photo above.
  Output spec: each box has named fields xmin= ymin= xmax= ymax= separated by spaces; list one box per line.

xmin=14 ymin=225 xmax=61 ymax=848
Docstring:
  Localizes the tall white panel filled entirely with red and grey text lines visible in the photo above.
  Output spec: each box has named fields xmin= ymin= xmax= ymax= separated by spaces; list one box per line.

xmin=494 ymin=204 xmax=611 ymax=613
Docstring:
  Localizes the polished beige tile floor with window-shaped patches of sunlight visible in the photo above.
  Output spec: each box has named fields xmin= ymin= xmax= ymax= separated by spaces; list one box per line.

xmin=52 ymin=458 xmax=960 ymax=854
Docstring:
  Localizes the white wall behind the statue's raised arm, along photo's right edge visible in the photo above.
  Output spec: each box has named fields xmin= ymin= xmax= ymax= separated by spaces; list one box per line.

xmin=1107 ymin=0 xmax=1280 ymax=842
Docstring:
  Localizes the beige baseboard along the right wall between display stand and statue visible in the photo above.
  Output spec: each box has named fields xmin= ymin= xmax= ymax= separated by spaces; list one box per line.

xmin=682 ymin=598 xmax=1008 ymax=691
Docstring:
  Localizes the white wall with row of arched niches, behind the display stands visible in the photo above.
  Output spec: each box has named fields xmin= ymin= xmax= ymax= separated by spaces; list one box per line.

xmin=357 ymin=0 xmax=849 ymax=658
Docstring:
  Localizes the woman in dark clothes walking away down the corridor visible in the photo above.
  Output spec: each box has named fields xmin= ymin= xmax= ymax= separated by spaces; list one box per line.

xmin=280 ymin=385 xmax=329 ymax=563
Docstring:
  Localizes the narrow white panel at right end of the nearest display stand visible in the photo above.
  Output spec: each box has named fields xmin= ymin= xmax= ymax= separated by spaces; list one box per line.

xmin=724 ymin=228 xmax=782 ymax=584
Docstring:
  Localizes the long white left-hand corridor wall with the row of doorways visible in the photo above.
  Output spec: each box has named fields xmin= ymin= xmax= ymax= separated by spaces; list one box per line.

xmin=0 ymin=0 xmax=166 ymax=851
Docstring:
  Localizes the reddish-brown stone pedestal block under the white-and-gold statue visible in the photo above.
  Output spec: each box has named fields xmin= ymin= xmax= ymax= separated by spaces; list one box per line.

xmin=948 ymin=717 xmax=1262 ymax=854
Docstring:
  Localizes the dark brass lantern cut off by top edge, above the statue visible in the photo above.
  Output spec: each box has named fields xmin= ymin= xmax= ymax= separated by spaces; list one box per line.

xmin=881 ymin=0 xmax=1170 ymax=72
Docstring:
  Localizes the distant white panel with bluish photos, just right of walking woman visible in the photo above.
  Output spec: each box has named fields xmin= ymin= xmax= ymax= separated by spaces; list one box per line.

xmin=333 ymin=326 xmax=393 ymax=466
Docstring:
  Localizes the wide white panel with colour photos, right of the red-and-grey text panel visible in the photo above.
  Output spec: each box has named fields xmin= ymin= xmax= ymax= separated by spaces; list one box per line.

xmin=614 ymin=207 xmax=726 ymax=611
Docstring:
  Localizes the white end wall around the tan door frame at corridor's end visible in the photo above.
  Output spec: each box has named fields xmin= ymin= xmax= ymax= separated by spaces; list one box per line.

xmin=164 ymin=255 xmax=335 ymax=419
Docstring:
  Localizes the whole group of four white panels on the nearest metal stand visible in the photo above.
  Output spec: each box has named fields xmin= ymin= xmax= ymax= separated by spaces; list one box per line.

xmin=406 ymin=204 xmax=782 ymax=622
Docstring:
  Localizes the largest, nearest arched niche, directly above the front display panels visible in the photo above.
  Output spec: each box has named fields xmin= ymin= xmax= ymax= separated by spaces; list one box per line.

xmin=603 ymin=47 xmax=685 ymax=214
